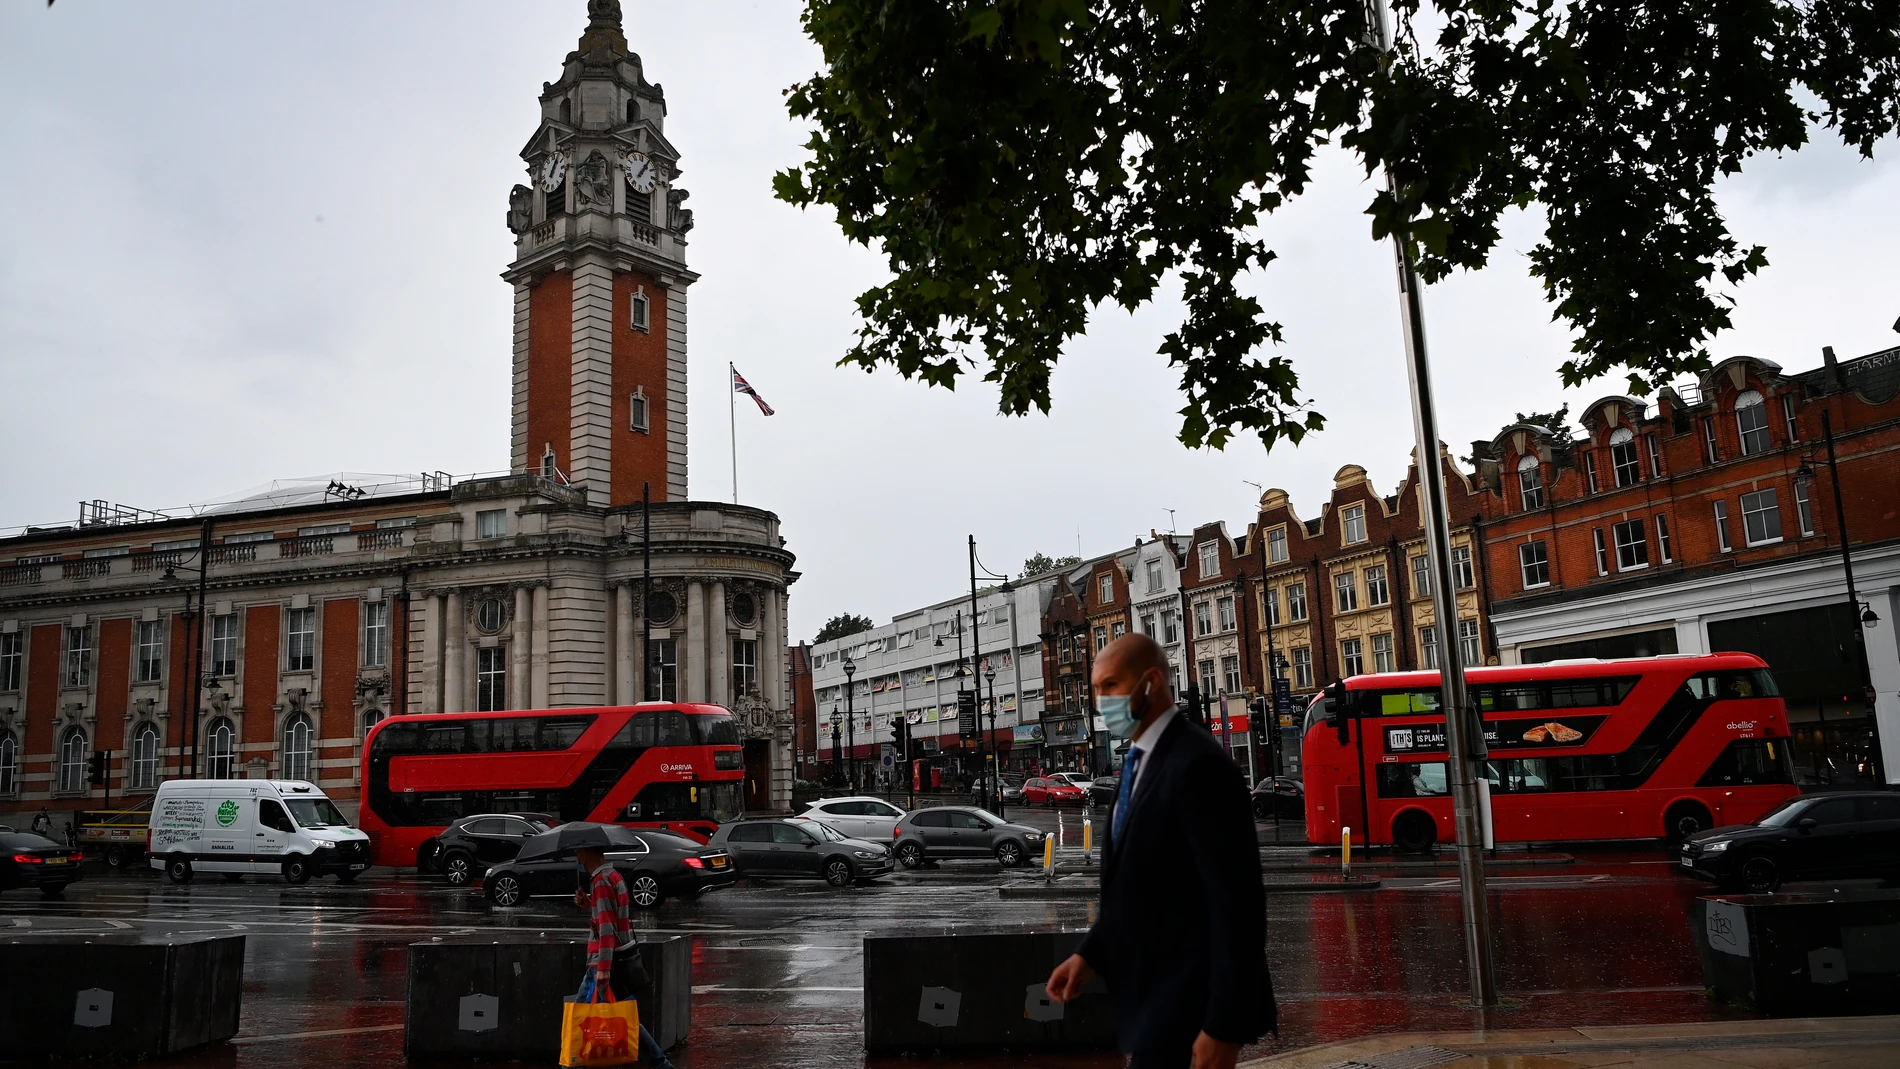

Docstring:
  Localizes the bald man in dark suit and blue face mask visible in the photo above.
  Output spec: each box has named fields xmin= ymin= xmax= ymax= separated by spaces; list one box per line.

xmin=1049 ymin=634 xmax=1279 ymax=1069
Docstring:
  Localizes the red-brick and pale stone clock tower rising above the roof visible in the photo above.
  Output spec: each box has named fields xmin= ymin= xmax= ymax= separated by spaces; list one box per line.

xmin=502 ymin=0 xmax=697 ymax=505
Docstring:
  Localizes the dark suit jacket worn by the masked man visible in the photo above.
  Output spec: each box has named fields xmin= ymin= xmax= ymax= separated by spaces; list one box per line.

xmin=1077 ymin=712 xmax=1279 ymax=1054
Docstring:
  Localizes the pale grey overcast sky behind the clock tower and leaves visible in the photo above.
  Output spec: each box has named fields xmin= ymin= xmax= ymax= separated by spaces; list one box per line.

xmin=0 ymin=0 xmax=1900 ymax=640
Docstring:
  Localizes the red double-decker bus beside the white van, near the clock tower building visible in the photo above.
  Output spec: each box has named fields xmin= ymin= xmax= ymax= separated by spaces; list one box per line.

xmin=357 ymin=703 xmax=745 ymax=866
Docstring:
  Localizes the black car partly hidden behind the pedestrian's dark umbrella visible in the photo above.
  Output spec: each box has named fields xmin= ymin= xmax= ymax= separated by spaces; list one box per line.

xmin=481 ymin=824 xmax=739 ymax=910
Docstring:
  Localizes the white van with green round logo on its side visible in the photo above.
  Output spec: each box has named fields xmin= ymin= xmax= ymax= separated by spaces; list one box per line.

xmin=146 ymin=780 xmax=369 ymax=883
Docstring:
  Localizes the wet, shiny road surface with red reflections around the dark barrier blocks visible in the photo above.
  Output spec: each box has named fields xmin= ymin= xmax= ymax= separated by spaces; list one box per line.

xmin=0 ymin=813 xmax=1824 ymax=1069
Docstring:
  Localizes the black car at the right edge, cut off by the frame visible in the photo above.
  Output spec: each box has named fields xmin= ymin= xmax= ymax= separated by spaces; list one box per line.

xmin=1682 ymin=792 xmax=1900 ymax=894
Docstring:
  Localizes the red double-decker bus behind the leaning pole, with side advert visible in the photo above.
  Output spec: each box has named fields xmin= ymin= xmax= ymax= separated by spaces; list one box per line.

xmin=1302 ymin=653 xmax=1797 ymax=851
